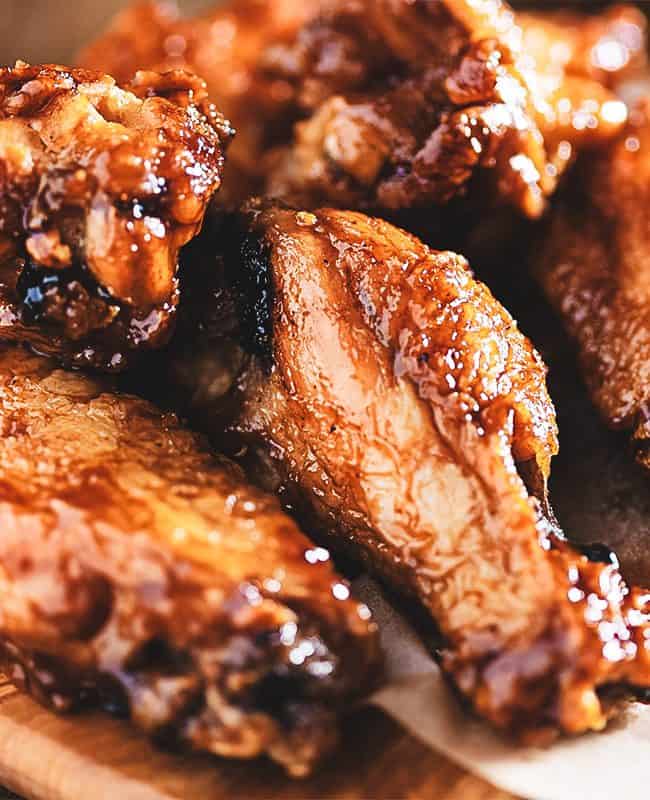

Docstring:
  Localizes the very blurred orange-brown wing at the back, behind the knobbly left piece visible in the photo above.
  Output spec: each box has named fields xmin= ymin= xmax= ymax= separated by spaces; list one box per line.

xmin=79 ymin=0 xmax=321 ymax=202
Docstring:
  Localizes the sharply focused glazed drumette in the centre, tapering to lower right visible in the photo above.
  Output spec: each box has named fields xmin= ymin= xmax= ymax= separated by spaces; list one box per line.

xmin=167 ymin=206 xmax=650 ymax=741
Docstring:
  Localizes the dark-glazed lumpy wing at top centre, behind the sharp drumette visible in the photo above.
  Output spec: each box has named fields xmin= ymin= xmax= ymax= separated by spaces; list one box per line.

xmin=263 ymin=0 xmax=632 ymax=217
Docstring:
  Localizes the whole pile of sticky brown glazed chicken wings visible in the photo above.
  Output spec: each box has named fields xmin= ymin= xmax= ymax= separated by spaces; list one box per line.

xmin=0 ymin=0 xmax=650 ymax=776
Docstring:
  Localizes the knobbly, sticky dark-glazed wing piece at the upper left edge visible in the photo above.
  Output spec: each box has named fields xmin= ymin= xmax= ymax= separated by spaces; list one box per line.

xmin=0 ymin=62 xmax=231 ymax=369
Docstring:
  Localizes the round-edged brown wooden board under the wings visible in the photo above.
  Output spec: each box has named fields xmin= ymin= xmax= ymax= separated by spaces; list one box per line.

xmin=0 ymin=675 xmax=512 ymax=800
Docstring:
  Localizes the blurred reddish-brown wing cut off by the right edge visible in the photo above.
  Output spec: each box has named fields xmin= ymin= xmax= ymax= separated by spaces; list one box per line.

xmin=536 ymin=100 xmax=650 ymax=476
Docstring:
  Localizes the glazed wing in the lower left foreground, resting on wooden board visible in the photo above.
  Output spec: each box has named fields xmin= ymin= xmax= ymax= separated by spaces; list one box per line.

xmin=0 ymin=344 xmax=378 ymax=775
